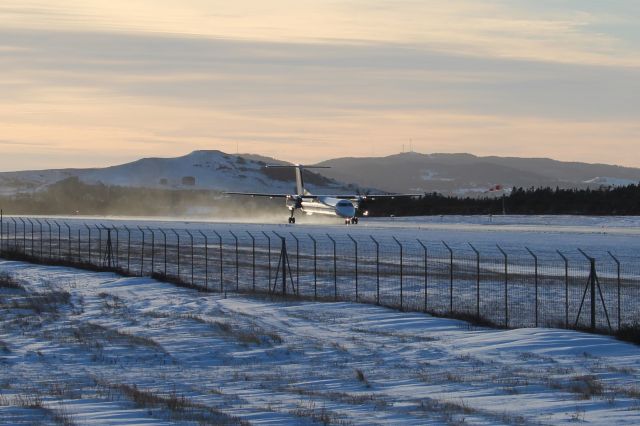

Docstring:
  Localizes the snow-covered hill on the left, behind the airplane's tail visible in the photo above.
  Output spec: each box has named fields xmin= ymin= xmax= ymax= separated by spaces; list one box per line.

xmin=0 ymin=151 xmax=354 ymax=195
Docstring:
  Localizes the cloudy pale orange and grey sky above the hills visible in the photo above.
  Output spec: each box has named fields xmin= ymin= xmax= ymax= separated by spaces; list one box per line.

xmin=0 ymin=0 xmax=640 ymax=171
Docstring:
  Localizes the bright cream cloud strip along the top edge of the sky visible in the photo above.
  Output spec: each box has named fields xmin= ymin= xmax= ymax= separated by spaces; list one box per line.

xmin=5 ymin=0 xmax=640 ymax=65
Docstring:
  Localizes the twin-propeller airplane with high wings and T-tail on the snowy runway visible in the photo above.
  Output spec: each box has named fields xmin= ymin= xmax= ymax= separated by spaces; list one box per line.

xmin=225 ymin=164 xmax=419 ymax=225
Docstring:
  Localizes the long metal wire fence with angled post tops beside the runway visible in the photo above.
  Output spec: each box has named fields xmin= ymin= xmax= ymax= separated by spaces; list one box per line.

xmin=0 ymin=217 xmax=640 ymax=332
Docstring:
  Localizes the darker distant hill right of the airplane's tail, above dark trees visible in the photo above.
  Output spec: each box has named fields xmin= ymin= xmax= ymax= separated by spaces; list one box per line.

xmin=318 ymin=152 xmax=640 ymax=195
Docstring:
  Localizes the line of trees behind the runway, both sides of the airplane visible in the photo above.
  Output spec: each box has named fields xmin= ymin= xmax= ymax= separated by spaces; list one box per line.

xmin=0 ymin=178 xmax=640 ymax=218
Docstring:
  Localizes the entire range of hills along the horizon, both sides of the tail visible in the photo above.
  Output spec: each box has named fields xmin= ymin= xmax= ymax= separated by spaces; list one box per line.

xmin=0 ymin=150 xmax=640 ymax=196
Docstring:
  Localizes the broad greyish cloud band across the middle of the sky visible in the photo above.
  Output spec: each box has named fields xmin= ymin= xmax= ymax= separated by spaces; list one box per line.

xmin=0 ymin=30 xmax=640 ymax=120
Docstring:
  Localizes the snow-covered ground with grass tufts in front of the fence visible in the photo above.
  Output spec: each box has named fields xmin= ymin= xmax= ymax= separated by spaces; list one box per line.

xmin=0 ymin=261 xmax=640 ymax=425
